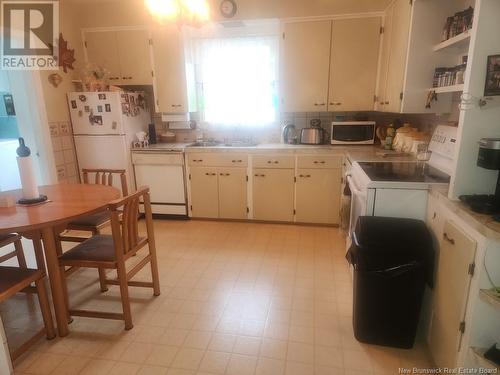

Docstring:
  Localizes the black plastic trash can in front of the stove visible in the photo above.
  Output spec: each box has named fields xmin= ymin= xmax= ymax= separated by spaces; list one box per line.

xmin=346 ymin=216 xmax=434 ymax=348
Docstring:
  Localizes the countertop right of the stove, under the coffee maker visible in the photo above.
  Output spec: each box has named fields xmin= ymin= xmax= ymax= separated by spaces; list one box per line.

xmin=430 ymin=186 xmax=500 ymax=242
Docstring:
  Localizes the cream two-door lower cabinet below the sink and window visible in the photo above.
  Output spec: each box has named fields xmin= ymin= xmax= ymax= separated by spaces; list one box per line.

xmin=190 ymin=167 xmax=247 ymax=219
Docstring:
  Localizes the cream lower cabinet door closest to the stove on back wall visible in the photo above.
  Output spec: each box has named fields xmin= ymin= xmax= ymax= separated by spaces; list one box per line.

xmin=295 ymin=169 xmax=342 ymax=224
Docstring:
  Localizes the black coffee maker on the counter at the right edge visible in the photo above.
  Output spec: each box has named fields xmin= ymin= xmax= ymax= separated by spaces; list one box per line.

xmin=458 ymin=138 xmax=500 ymax=215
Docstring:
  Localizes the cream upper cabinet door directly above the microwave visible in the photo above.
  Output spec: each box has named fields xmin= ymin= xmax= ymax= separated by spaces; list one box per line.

xmin=328 ymin=17 xmax=381 ymax=112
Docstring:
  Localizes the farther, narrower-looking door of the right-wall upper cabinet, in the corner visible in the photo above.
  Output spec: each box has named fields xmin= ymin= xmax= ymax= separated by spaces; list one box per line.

xmin=375 ymin=5 xmax=394 ymax=111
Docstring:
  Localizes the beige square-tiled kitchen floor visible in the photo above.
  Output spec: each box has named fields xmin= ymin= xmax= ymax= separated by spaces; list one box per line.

xmin=0 ymin=221 xmax=429 ymax=375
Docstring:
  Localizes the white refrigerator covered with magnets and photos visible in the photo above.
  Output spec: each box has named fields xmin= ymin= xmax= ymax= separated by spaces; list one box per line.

xmin=68 ymin=92 xmax=151 ymax=190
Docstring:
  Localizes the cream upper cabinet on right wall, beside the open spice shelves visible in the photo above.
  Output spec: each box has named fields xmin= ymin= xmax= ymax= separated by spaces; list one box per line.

xmin=375 ymin=0 xmax=456 ymax=113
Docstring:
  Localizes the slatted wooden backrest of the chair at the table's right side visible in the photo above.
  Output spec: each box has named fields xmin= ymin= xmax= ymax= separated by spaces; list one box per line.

xmin=108 ymin=187 xmax=149 ymax=255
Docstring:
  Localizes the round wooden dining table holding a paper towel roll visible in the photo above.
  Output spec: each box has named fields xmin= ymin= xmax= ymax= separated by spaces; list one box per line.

xmin=0 ymin=184 xmax=121 ymax=336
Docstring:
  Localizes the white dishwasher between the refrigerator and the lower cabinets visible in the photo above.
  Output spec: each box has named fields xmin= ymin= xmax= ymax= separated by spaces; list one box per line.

xmin=132 ymin=151 xmax=187 ymax=218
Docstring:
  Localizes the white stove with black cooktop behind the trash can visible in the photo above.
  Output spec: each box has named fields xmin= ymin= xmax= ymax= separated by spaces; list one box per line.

xmin=347 ymin=125 xmax=457 ymax=235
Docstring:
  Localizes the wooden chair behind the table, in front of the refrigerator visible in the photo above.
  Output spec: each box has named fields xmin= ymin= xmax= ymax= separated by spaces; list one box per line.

xmin=59 ymin=169 xmax=128 ymax=242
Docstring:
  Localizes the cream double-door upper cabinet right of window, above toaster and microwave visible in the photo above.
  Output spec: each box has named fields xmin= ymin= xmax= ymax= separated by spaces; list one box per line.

xmin=282 ymin=17 xmax=381 ymax=112
